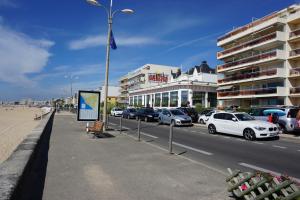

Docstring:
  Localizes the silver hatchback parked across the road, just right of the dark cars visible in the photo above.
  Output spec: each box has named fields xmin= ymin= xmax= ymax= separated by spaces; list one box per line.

xmin=158 ymin=109 xmax=193 ymax=126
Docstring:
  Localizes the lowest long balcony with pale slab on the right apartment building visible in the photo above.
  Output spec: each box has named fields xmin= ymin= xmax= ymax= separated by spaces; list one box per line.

xmin=218 ymin=87 xmax=287 ymax=100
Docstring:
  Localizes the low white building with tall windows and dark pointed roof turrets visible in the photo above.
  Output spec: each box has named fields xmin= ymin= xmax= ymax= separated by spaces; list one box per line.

xmin=129 ymin=61 xmax=217 ymax=108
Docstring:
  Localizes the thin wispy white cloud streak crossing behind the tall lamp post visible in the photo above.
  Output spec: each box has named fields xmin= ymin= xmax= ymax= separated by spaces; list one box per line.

xmin=69 ymin=35 xmax=164 ymax=50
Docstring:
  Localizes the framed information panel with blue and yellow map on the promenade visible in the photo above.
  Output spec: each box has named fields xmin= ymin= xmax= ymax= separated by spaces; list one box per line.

xmin=77 ymin=91 xmax=100 ymax=121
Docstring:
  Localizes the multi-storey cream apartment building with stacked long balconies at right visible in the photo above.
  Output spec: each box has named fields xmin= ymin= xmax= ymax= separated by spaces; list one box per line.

xmin=217 ymin=4 xmax=300 ymax=107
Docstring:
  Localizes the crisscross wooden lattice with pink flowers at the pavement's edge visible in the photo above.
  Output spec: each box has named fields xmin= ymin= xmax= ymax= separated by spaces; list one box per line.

xmin=226 ymin=169 xmax=300 ymax=200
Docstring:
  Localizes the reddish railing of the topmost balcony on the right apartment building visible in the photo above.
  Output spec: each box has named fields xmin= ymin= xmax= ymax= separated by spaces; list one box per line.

xmin=218 ymin=12 xmax=278 ymax=42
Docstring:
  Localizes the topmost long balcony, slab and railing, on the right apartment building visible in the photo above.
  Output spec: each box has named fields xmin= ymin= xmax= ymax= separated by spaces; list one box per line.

xmin=217 ymin=12 xmax=286 ymax=46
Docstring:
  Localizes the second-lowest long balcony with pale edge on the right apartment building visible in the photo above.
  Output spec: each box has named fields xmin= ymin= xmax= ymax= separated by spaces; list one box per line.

xmin=218 ymin=68 xmax=286 ymax=85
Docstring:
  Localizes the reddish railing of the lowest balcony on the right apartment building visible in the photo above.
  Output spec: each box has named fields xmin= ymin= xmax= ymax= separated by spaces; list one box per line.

xmin=218 ymin=87 xmax=277 ymax=97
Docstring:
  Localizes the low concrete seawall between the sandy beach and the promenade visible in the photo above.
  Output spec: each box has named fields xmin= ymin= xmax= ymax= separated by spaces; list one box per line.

xmin=0 ymin=112 xmax=54 ymax=200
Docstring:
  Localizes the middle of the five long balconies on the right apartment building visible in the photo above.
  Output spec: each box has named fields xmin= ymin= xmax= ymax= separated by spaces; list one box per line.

xmin=217 ymin=50 xmax=285 ymax=72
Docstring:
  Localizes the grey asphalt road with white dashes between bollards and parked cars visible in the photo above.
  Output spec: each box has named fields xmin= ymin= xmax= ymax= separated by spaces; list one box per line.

xmin=109 ymin=117 xmax=300 ymax=181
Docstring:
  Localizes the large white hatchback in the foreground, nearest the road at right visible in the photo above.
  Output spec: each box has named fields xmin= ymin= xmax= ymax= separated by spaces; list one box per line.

xmin=206 ymin=112 xmax=279 ymax=140
